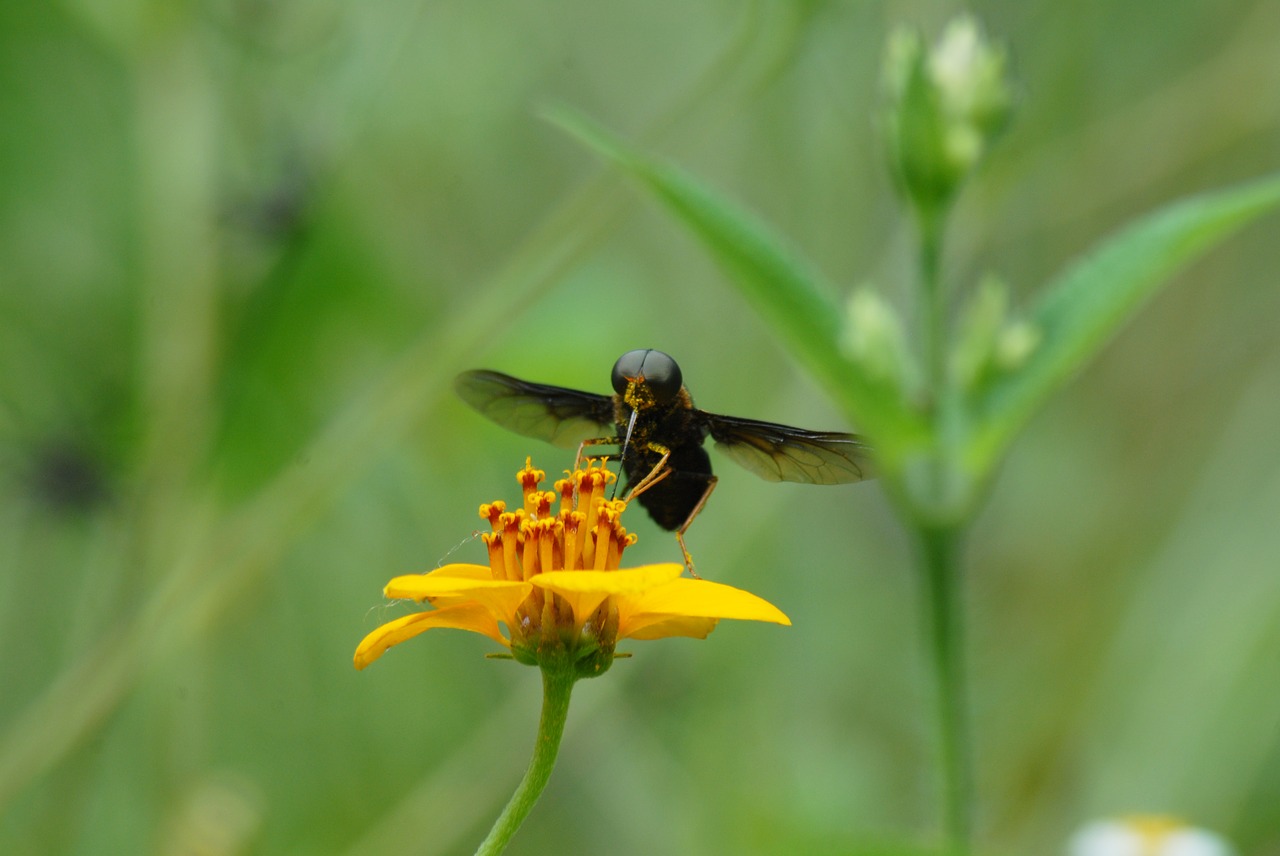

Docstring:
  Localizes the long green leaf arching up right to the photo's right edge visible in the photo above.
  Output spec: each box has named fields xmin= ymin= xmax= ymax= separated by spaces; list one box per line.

xmin=969 ymin=175 xmax=1280 ymax=472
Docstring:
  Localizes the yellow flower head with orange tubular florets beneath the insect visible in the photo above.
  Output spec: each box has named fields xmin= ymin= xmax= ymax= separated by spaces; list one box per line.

xmin=356 ymin=461 xmax=791 ymax=677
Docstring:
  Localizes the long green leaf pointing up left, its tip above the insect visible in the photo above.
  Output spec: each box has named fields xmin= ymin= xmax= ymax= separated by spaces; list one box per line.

xmin=548 ymin=110 xmax=924 ymax=450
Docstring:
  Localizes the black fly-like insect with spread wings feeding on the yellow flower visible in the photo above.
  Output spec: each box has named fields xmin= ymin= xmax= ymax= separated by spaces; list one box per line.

xmin=454 ymin=348 xmax=870 ymax=569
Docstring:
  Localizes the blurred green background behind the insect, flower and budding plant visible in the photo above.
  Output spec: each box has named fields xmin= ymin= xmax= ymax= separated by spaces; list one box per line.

xmin=0 ymin=0 xmax=1280 ymax=856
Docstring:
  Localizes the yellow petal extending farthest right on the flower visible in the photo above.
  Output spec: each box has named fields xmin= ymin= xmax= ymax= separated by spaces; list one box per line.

xmin=617 ymin=578 xmax=791 ymax=638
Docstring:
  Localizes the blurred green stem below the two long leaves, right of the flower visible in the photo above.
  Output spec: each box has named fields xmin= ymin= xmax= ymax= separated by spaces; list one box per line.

xmin=916 ymin=526 xmax=973 ymax=856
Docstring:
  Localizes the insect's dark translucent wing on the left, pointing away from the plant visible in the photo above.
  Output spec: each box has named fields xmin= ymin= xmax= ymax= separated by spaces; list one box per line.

xmin=453 ymin=370 xmax=616 ymax=449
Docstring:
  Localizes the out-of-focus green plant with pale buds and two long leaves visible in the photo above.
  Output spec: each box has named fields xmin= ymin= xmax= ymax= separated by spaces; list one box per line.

xmin=552 ymin=19 xmax=1280 ymax=853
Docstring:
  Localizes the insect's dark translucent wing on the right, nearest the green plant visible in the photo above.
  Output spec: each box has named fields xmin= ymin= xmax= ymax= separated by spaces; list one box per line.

xmin=701 ymin=412 xmax=874 ymax=485
